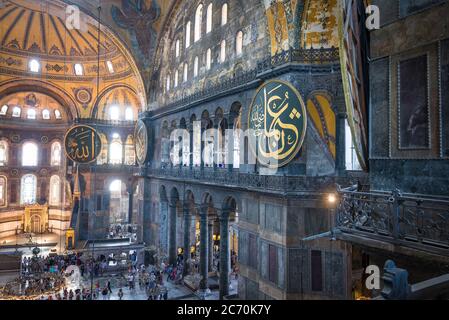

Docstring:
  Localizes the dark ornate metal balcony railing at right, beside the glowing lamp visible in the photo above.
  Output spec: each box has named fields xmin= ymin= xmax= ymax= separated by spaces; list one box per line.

xmin=336 ymin=188 xmax=449 ymax=251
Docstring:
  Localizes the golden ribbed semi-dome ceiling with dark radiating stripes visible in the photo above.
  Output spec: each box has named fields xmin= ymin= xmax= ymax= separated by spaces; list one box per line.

xmin=0 ymin=1 xmax=120 ymax=60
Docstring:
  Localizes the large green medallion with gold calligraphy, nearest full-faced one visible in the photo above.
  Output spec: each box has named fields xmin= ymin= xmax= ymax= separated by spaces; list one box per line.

xmin=248 ymin=80 xmax=307 ymax=168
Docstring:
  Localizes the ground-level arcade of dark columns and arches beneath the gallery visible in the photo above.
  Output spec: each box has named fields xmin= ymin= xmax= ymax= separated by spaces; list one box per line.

xmin=159 ymin=185 xmax=240 ymax=298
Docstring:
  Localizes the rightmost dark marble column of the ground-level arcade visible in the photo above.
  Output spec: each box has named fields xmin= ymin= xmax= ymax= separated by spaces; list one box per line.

xmin=219 ymin=211 xmax=229 ymax=300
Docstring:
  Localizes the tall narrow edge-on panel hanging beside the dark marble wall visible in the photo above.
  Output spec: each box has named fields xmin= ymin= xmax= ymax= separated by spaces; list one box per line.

xmin=339 ymin=0 xmax=369 ymax=170
